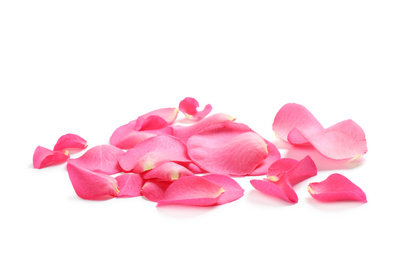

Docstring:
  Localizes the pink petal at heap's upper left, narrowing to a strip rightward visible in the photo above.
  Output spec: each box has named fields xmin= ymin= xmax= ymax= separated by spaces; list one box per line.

xmin=110 ymin=120 xmax=173 ymax=149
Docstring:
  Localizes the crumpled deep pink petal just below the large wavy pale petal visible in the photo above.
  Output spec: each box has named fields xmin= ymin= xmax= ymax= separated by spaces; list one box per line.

xmin=267 ymin=155 xmax=317 ymax=185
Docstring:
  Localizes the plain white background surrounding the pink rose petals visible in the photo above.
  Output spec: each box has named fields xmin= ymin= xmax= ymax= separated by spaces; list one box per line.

xmin=0 ymin=0 xmax=417 ymax=259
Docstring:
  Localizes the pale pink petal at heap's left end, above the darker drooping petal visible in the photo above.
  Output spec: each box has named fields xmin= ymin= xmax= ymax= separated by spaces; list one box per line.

xmin=68 ymin=144 xmax=124 ymax=174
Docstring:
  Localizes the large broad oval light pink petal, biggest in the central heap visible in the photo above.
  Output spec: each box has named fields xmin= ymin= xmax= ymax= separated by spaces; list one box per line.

xmin=187 ymin=122 xmax=268 ymax=176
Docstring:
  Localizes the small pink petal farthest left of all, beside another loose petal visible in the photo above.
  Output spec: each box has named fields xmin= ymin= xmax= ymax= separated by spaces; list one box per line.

xmin=33 ymin=146 xmax=69 ymax=169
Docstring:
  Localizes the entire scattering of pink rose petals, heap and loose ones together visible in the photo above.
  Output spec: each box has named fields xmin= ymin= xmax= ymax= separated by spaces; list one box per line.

xmin=33 ymin=97 xmax=367 ymax=206
